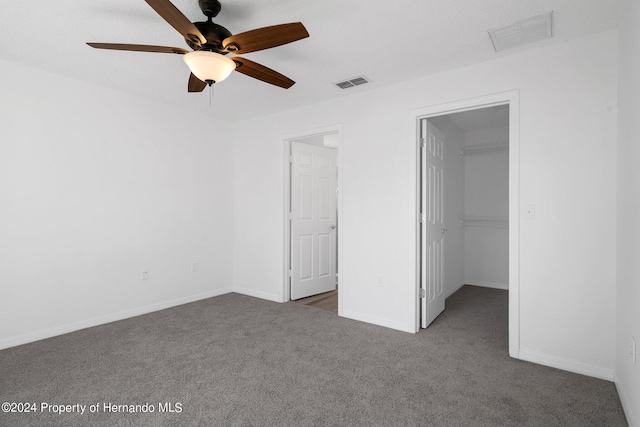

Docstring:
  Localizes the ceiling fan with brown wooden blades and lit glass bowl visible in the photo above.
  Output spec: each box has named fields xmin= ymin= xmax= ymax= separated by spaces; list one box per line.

xmin=87 ymin=0 xmax=309 ymax=92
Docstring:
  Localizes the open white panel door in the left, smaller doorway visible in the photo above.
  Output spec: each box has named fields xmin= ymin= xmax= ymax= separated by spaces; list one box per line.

xmin=290 ymin=142 xmax=337 ymax=300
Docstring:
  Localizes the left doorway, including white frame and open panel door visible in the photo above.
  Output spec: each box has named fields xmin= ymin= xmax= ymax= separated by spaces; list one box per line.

xmin=282 ymin=125 xmax=343 ymax=314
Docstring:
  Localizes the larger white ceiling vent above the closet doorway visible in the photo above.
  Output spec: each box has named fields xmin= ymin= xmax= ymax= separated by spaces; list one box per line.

xmin=489 ymin=12 xmax=553 ymax=52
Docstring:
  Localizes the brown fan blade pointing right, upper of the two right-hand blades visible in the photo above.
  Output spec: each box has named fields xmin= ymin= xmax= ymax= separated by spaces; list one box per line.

xmin=222 ymin=22 xmax=309 ymax=53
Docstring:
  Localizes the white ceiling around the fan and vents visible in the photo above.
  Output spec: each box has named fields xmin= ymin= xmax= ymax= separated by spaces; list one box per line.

xmin=0 ymin=0 xmax=621 ymax=120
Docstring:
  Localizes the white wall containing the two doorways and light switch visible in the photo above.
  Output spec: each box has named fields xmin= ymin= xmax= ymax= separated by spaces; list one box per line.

xmin=234 ymin=31 xmax=617 ymax=378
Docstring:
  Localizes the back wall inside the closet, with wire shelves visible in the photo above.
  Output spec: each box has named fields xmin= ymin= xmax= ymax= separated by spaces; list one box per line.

xmin=464 ymin=127 xmax=509 ymax=289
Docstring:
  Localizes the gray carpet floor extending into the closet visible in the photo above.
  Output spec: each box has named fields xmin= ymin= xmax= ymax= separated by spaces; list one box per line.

xmin=0 ymin=286 xmax=627 ymax=426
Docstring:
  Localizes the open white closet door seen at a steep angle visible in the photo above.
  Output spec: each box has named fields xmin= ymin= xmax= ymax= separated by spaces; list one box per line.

xmin=420 ymin=119 xmax=446 ymax=328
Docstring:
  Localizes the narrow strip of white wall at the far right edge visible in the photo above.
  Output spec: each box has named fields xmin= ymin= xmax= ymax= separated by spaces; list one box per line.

xmin=616 ymin=0 xmax=640 ymax=426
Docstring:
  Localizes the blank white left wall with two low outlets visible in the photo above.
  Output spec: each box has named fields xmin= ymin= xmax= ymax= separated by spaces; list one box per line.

xmin=0 ymin=61 xmax=233 ymax=348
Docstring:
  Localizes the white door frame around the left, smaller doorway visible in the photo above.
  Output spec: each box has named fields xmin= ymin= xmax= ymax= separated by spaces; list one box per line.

xmin=280 ymin=123 xmax=345 ymax=316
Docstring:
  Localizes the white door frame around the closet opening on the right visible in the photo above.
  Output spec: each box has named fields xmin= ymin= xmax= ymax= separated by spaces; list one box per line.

xmin=409 ymin=89 xmax=520 ymax=358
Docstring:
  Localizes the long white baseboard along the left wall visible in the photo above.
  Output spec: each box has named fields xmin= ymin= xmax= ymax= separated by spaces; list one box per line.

xmin=0 ymin=288 xmax=232 ymax=350
